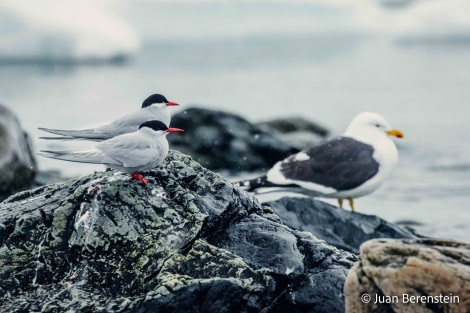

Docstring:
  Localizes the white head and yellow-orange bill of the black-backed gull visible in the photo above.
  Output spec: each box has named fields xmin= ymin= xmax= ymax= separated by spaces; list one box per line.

xmin=344 ymin=112 xmax=403 ymax=144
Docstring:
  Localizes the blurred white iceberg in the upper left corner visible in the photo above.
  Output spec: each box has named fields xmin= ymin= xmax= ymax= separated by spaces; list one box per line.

xmin=0 ymin=0 xmax=140 ymax=63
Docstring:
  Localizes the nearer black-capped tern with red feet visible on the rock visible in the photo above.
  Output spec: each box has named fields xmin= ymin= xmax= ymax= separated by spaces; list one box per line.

xmin=38 ymin=121 xmax=183 ymax=185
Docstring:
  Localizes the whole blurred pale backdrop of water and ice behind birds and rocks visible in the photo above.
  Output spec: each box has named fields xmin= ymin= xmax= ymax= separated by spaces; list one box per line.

xmin=0 ymin=0 xmax=470 ymax=241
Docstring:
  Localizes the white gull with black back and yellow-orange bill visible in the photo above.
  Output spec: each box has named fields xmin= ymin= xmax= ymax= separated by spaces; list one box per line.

xmin=235 ymin=112 xmax=404 ymax=212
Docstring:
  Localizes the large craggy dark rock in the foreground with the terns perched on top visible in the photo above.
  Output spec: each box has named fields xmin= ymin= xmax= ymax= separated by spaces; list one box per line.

xmin=0 ymin=151 xmax=357 ymax=313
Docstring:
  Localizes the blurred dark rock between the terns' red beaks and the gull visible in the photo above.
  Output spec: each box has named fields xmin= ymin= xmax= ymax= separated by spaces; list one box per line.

xmin=168 ymin=108 xmax=299 ymax=171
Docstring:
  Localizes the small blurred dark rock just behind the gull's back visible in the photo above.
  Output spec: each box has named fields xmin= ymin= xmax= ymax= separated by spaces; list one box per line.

xmin=256 ymin=117 xmax=330 ymax=150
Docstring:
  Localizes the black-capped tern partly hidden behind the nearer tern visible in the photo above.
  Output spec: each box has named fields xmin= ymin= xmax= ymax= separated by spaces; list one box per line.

xmin=39 ymin=94 xmax=179 ymax=141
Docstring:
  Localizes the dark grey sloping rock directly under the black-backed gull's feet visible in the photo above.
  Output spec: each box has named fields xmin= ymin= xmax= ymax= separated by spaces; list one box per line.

xmin=265 ymin=197 xmax=416 ymax=254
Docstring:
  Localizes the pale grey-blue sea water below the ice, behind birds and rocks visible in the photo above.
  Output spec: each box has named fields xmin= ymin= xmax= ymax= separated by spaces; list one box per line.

xmin=0 ymin=4 xmax=470 ymax=241
